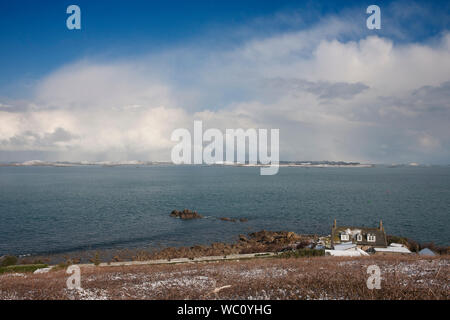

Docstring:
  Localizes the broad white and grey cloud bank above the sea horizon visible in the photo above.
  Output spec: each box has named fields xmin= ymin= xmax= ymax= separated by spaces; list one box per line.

xmin=0 ymin=9 xmax=450 ymax=164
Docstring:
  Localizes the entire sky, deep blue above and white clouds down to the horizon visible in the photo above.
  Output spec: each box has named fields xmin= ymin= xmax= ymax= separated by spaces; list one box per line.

xmin=0 ymin=0 xmax=450 ymax=164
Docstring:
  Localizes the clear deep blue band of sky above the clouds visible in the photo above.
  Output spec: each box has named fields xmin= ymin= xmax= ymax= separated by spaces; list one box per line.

xmin=0 ymin=0 xmax=450 ymax=96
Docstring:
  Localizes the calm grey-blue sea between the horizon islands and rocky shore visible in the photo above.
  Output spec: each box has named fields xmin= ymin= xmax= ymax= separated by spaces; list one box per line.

xmin=0 ymin=166 xmax=450 ymax=255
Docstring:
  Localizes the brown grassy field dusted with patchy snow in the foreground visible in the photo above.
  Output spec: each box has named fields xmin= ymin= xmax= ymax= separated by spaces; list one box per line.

xmin=0 ymin=256 xmax=450 ymax=300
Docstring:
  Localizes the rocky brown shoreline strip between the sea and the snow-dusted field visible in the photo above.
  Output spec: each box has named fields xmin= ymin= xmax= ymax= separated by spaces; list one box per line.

xmin=9 ymin=230 xmax=450 ymax=265
